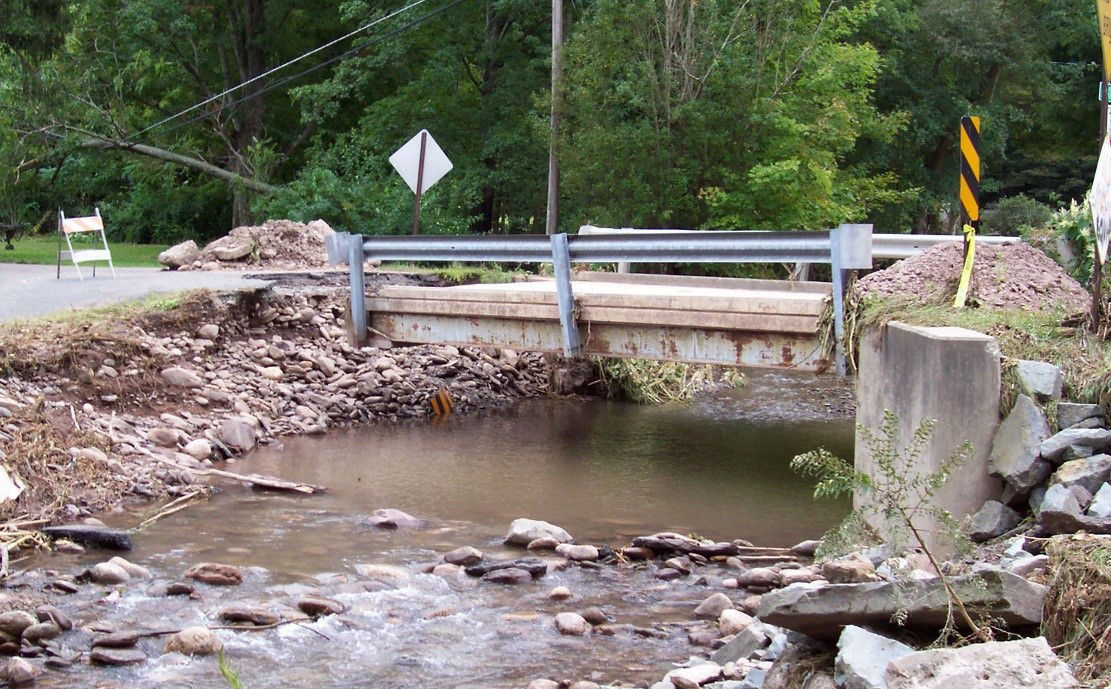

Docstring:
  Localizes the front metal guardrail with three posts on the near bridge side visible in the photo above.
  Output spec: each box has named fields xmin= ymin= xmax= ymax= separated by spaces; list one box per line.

xmin=328 ymin=224 xmax=872 ymax=376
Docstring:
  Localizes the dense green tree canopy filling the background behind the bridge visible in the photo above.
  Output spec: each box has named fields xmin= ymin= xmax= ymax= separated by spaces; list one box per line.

xmin=0 ymin=0 xmax=1100 ymax=242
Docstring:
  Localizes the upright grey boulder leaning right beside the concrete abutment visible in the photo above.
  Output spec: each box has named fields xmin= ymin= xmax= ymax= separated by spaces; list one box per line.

xmin=989 ymin=395 xmax=1053 ymax=495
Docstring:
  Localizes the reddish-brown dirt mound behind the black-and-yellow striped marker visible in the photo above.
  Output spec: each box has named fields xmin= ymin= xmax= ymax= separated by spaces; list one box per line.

xmin=857 ymin=242 xmax=1089 ymax=313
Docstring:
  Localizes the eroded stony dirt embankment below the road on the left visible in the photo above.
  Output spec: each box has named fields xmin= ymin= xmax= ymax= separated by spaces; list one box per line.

xmin=0 ymin=290 xmax=549 ymax=521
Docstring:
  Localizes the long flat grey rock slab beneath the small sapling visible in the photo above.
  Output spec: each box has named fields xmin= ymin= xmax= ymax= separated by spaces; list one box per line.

xmin=757 ymin=569 xmax=1045 ymax=641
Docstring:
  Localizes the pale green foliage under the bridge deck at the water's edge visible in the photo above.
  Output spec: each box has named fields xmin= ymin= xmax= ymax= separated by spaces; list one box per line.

xmin=597 ymin=359 xmax=744 ymax=405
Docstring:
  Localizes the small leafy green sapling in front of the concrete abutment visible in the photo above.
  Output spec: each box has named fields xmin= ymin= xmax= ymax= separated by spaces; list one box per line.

xmin=791 ymin=410 xmax=991 ymax=641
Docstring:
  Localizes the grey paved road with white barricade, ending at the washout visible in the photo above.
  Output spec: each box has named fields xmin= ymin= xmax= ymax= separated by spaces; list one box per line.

xmin=0 ymin=263 xmax=267 ymax=321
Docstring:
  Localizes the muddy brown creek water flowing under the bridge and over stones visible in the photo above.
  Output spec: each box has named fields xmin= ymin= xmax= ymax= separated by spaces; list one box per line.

xmin=34 ymin=375 xmax=851 ymax=689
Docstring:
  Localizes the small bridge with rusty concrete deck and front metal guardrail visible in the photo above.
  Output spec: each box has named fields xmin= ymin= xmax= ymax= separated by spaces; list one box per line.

xmin=328 ymin=224 xmax=872 ymax=373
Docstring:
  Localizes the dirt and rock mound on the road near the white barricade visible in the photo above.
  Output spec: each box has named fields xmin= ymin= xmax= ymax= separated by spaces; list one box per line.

xmin=159 ymin=220 xmax=333 ymax=270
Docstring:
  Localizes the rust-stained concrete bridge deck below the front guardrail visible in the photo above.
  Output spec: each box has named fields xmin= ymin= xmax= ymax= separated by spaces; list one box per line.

xmin=367 ymin=273 xmax=831 ymax=371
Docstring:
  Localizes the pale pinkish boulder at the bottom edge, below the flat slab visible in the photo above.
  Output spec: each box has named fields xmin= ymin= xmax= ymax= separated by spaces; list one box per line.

xmin=884 ymin=637 xmax=1077 ymax=689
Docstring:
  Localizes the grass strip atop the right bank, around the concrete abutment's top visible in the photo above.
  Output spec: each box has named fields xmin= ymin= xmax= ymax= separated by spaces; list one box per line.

xmin=845 ymin=298 xmax=1111 ymax=412
